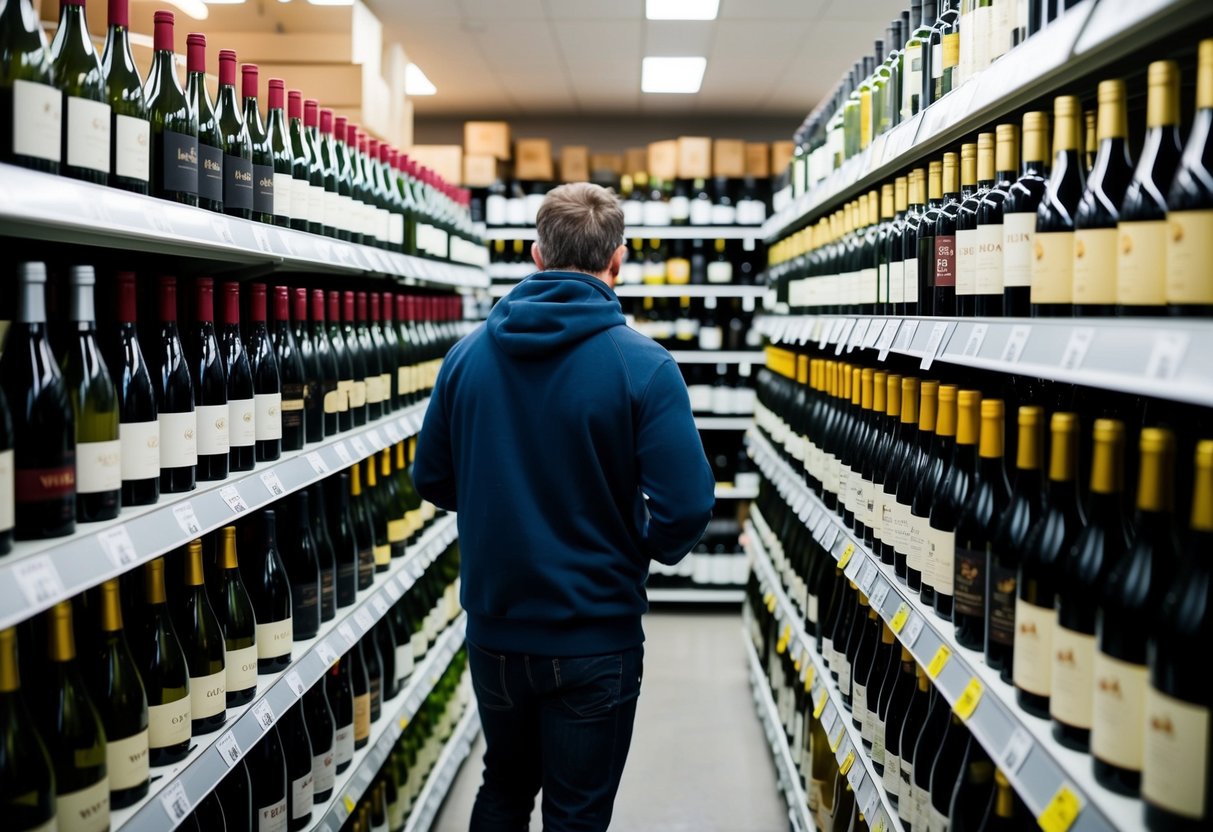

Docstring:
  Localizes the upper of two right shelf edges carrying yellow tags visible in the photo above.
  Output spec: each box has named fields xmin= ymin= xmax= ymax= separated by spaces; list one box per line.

xmin=750 ymin=431 xmax=1141 ymax=832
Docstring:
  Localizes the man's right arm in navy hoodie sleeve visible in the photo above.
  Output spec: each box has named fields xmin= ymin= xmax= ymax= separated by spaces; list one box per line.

xmin=636 ymin=359 xmax=716 ymax=564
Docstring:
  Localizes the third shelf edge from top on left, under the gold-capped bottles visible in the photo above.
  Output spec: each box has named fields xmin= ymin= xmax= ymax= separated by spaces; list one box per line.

xmin=112 ymin=515 xmax=459 ymax=832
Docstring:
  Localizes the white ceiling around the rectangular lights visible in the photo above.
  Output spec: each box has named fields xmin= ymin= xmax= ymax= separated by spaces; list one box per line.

xmin=366 ymin=0 xmax=906 ymax=118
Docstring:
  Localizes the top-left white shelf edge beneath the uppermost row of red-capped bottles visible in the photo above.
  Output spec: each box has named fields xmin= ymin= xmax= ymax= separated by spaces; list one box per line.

xmin=0 ymin=165 xmax=489 ymax=289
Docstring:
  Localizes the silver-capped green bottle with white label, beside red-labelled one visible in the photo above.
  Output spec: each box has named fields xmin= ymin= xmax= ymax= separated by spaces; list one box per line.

xmin=63 ymin=266 xmax=123 ymax=523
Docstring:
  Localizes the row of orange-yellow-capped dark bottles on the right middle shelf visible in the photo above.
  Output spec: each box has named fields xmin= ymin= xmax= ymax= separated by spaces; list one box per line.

xmin=756 ymin=355 xmax=1213 ymax=828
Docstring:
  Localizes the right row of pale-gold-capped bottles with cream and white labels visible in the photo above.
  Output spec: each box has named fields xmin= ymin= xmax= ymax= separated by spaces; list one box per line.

xmin=770 ymin=40 xmax=1213 ymax=317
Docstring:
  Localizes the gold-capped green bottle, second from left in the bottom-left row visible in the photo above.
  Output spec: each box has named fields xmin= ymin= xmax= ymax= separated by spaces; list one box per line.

xmin=38 ymin=600 xmax=109 ymax=832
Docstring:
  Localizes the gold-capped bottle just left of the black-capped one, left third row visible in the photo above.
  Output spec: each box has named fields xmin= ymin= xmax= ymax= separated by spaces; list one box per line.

xmin=211 ymin=526 xmax=257 ymax=708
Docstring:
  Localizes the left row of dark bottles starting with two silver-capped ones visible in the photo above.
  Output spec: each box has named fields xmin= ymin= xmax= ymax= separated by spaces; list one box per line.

xmin=0 ymin=263 xmax=463 ymax=553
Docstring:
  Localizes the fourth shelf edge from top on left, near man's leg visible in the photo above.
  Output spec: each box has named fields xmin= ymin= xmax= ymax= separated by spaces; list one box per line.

xmin=308 ymin=614 xmax=475 ymax=832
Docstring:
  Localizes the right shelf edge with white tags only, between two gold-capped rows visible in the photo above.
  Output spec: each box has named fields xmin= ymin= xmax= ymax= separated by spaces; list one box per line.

xmin=754 ymin=315 xmax=1213 ymax=406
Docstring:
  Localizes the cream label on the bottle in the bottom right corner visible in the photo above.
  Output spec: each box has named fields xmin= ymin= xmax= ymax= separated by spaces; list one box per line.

xmin=1141 ymin=685 xmax=1209 ymax=822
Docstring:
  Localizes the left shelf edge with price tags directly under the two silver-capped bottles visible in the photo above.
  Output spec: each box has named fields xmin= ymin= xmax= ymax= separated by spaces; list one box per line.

xmin=0 ymin=399 xmax=428 ymax=628
